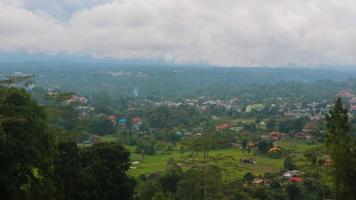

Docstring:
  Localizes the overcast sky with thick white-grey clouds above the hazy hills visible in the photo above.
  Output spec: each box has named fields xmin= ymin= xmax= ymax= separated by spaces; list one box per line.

xmin=0 ymin=0 xmax=356 ymax=67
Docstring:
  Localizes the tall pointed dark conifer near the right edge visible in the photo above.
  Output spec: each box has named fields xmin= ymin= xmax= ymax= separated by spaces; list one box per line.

xmin=326 ymin=98 xmax=356 ymax=200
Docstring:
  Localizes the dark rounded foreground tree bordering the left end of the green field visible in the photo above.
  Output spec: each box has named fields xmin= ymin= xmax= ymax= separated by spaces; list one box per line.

xmin=80 ymin=142 xmax=135 ymax=200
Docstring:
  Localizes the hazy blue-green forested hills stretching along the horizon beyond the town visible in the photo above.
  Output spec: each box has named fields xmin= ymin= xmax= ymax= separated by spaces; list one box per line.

xmin=0 ymin=62 xmax=356 ymax=99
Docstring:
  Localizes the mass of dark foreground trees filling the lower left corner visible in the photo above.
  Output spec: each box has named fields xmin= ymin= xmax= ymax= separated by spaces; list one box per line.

xmin=0 ymin=87 xmax=135 ymax=200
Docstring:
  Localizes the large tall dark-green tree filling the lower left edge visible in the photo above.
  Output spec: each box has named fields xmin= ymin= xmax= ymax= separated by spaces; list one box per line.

xmin=0 ymin=87 xmax=55 ymax=199
